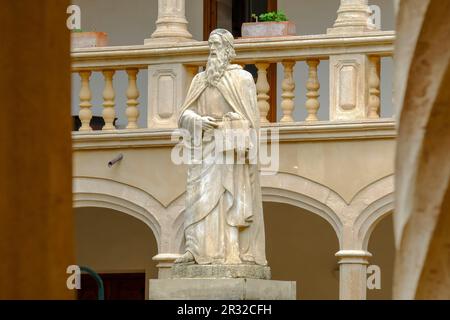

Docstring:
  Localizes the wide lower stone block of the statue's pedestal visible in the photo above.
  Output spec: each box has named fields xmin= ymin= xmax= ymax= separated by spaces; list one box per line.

xmin=149 ymin=279 xmax=296 ymax=300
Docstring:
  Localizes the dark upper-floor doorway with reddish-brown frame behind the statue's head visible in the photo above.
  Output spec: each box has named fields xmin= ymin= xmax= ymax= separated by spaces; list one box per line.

xmin=203 ymin=0 xmax=277 ymax=122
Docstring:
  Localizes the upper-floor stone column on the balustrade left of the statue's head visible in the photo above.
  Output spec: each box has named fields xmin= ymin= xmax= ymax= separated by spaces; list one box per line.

xmin=144 ymin=0 xmax=192 ymax=44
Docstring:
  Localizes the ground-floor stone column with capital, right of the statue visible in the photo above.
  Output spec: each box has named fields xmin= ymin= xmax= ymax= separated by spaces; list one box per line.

xmin=336 ymin=250 xmax=372 ymax=300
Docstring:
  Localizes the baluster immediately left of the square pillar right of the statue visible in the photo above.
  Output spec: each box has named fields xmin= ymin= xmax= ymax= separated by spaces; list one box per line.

xmin=305 ymin=59 xmax=320 ymax=122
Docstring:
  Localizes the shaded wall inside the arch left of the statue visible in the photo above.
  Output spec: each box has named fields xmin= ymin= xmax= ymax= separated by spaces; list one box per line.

xmin=75 ymin=208 xmax=157 ymax=275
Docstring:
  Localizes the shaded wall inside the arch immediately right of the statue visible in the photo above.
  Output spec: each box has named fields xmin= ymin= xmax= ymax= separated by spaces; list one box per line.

xmin=264 ymin=203 xmax=339 ymax=300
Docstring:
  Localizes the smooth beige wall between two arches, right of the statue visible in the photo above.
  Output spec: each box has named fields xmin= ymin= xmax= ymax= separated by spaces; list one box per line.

xmin=279 ymin=140 xmax=395 ymax=203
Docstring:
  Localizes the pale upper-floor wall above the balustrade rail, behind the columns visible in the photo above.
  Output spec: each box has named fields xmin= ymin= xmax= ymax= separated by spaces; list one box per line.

xmin=72 ymin=0 xmax=395 ymax=46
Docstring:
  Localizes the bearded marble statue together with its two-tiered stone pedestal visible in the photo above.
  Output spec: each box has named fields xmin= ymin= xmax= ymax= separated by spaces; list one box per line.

xmin=149 ymin=29 xmax=296 ymax=300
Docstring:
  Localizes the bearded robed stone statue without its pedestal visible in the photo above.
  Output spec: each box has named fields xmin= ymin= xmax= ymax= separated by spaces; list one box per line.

xmin=175 ymin=29 xmax=267 ymax=266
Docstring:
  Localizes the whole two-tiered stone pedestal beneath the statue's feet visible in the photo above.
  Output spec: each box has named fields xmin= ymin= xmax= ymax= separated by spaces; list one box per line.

xmin=149 ymin=264 xmax=296 ymax=300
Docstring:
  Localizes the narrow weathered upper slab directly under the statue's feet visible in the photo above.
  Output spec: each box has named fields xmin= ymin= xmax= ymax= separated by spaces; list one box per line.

xmin=171 ymin=264 xmax=271 ymax=280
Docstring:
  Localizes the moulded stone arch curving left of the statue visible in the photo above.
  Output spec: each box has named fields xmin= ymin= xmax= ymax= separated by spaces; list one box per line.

xmin=73 ymin=177 xmax=164 ymax=251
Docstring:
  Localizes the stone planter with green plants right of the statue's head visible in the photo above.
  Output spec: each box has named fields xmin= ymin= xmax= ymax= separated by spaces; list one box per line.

xmin=242 ymin=11 xmax=296 ymax=38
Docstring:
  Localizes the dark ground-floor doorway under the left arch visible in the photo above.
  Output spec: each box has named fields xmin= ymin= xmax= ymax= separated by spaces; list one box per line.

xmin=78 ymin=273 xmax=145 ymax=300
